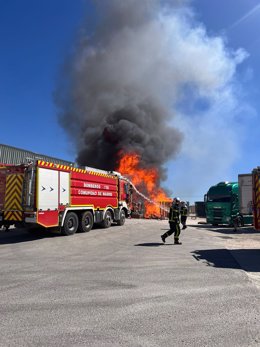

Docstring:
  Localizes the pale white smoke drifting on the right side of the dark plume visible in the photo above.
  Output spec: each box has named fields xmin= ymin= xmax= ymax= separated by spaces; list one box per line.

xmin=158 ymin=8 xmax=252 ymax=201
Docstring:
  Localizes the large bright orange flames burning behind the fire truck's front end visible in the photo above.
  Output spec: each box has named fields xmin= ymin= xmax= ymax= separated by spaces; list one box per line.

xmin=118 ymin=153 xmax=171 ymax=218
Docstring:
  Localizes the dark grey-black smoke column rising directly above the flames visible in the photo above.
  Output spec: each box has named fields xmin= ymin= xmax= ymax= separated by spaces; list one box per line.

xmin=56 ymin=0 xmax=182 ymax=179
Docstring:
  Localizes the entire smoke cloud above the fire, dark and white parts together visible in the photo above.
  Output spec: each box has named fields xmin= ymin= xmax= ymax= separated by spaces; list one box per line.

xmin=56 ymin=0 xmax=246 ymax=192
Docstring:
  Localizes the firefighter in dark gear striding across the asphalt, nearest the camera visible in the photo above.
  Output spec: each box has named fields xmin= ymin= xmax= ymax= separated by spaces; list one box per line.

xmin=161 ymin=198 xmax=181 ymax=245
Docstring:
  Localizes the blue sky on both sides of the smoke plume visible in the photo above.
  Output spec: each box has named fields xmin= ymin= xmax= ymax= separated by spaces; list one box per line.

xmin=0 ymin=0 xmax=260 ymax=201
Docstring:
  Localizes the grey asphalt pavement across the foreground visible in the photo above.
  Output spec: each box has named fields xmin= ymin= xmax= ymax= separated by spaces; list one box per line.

xmin=0 ymin=219 xmax=260 ymax=347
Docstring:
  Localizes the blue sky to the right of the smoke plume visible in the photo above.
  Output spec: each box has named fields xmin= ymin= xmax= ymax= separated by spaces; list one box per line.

xmin=170 ymin=0 xmax=260 ymax=201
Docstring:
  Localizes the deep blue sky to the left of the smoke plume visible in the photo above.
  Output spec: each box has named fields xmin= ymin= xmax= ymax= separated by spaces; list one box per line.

xmin=0 ymin=0 xmax=84 ymax=160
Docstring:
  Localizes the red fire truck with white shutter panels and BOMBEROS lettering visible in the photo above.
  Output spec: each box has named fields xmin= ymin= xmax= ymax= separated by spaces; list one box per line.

xmin=0 ymin=160 xmax=132 ymax=235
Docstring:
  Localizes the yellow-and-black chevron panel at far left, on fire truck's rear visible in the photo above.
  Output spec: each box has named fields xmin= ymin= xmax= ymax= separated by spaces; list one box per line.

xmin=4 ymin=174 xmax=23 ymax=221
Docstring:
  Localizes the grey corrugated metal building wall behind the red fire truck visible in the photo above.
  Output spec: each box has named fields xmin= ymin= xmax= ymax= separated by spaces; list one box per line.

xmin=0 ymin=144 xmax=76 ymax=167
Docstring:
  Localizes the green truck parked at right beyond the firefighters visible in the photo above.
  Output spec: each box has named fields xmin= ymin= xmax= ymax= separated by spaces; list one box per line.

xmin=205 ymin=174 xmax=253 ymax=226
